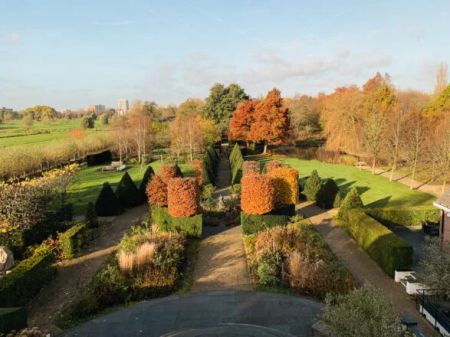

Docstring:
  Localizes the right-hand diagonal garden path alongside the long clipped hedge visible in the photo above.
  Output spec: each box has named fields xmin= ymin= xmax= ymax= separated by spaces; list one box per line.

xmin=299 ymin=203 xmax=438 ymax=337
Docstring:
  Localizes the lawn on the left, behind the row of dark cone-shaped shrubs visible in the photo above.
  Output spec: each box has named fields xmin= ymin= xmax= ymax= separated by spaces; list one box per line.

xmin=68 ymin=161 xmax=192 ymax=215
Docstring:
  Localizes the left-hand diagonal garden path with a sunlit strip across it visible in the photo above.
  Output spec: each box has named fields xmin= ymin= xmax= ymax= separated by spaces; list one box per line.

xmin=27 ymin=205 xmax=148 ymax=335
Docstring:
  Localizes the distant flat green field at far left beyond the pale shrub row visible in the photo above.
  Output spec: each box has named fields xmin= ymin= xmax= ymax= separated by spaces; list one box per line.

xmin=0 ymin=119 xmax=106 ymax=148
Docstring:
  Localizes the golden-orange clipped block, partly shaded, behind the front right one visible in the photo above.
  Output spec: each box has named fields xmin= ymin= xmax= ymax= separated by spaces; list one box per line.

xmin=267 ymin=167 xmax=298 ymax=205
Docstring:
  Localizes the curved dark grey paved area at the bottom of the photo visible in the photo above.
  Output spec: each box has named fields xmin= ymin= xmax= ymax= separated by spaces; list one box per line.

xmin=63 ymin=291 xmax=322 ymax=337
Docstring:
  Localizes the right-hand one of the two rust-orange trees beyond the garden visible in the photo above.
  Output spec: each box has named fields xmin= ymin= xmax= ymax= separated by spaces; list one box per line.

xmin=248 ymin=89 xmax=290 ymax=153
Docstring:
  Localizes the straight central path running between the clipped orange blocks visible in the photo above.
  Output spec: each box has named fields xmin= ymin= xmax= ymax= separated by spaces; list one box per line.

xmin=191 ymin=155 xmax=252 ymax=292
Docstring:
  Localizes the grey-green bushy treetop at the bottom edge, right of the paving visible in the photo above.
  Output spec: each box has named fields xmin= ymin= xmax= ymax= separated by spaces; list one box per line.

xmin=322 ymin=284 xmax=407 ymax=337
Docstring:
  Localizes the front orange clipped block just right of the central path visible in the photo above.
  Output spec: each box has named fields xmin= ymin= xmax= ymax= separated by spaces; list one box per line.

xmin=241 ymin=175 xmax=275 ymax=214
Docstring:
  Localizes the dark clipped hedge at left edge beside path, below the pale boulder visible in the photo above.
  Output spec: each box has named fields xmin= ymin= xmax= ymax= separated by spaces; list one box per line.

xmin=0 ymin=245 xmax=56 ymax=306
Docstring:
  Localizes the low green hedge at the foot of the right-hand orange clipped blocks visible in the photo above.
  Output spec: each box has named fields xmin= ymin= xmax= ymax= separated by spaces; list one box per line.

xmin=241 ymin=205 xmax=295 ymax=235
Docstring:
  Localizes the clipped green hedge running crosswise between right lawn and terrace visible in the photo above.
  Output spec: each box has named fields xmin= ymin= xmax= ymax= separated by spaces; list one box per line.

xmin=364 ymin=207 xmax=440 ymax=226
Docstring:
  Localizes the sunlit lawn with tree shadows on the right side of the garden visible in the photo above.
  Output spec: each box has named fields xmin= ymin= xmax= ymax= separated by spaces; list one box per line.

xmin=250 ymin=156 xmax=436 ymax=207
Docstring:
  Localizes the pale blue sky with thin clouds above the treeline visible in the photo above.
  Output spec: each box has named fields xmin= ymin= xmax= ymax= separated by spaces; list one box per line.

xmin=0 ymin=0 xmax=450 ymax=110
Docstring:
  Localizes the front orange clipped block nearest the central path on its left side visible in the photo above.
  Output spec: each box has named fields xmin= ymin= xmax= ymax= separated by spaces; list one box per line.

xmin=167 ymin=178 xmax=200 ymax=217
